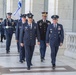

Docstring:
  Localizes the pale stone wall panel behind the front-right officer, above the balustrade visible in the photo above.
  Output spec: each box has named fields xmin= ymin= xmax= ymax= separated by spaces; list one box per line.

xmin=58 ymin=0 xmax=73 ymax=31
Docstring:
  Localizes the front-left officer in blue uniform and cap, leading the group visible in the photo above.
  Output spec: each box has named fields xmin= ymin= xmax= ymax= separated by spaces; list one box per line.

xmin=21 ymin=13 xmax=40 ymax=70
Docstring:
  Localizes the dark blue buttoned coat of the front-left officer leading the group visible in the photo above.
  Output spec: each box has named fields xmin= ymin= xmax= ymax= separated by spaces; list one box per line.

xmin=20 ymin=22 xmax=40 ymax=46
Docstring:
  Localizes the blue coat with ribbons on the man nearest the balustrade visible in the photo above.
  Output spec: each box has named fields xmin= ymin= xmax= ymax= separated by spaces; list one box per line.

xmin=46 ymin=24 xmax=64 ymax=46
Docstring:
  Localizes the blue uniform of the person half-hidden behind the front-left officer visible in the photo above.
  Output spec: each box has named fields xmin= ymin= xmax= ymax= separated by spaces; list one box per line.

xmin=16 ymin=21 xmax=26 ymax=63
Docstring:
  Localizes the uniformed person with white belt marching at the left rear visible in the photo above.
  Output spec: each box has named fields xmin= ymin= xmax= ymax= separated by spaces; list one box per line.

xmin=3 ymin=13 xmax=15 ymax=54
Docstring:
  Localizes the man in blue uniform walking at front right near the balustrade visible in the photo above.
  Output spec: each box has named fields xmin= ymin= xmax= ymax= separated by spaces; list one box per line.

xmin=46 ymin=15 xmax=64 ymax=69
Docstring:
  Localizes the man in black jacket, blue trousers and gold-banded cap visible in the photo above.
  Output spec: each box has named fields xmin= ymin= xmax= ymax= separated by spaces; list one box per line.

xmin=37 ymin=12 xmax=51 ymax=62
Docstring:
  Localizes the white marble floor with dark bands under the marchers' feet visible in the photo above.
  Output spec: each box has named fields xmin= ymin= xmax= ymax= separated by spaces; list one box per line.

xmin=0 ymin=34 xmax=76 ymax=75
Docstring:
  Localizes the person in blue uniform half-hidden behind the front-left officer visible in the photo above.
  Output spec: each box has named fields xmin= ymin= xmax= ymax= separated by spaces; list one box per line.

xmin=16 ymin=14 xmax=26 ymax=63
